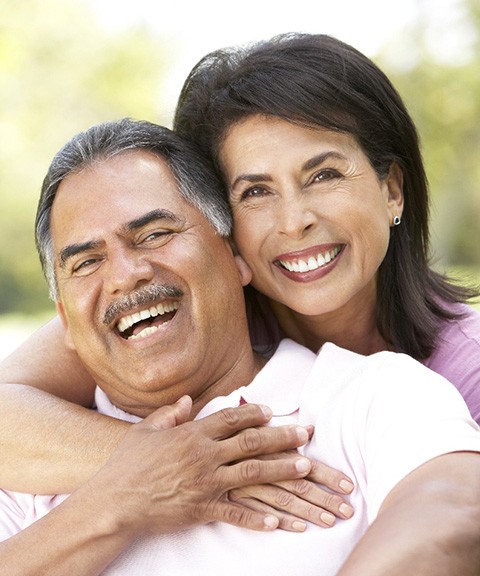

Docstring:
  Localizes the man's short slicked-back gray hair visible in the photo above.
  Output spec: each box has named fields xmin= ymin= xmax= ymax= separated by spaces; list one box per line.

xmin=35 ymin=118 xmax=232 ymax=301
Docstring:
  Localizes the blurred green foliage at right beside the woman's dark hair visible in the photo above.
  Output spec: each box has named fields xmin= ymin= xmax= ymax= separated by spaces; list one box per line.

xmin=382 ymin=0 xmax=480 ymax=272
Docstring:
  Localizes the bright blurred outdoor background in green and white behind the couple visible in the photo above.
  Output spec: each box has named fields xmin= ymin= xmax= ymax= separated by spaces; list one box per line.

xmin=0 ymin=0 xmax=480 ymax=359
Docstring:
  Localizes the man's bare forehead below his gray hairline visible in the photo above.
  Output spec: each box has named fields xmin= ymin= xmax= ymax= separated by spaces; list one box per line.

xmin=52 ymin=150 xmax=205 ymax=246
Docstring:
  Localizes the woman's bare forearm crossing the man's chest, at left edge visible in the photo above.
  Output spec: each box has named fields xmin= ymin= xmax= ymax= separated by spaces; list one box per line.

xmin=0 ymin=384 xmax=130 ymax=494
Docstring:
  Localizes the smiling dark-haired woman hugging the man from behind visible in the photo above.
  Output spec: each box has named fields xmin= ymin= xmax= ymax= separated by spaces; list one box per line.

xmin=1 ymin=35 xmax=480 ymax=520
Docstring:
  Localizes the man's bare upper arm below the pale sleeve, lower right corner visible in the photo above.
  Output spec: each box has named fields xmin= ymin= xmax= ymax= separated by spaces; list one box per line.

xmin=338 ymin=452 xmax=480 ymax=576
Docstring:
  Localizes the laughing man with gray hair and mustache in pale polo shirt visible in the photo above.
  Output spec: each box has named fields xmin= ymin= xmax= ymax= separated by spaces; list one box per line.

xmin=0 ymin=121 xmax=480 ymax=576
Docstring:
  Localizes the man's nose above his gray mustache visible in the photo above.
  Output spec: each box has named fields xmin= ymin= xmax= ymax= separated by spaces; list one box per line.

xmin=104 ymin=248 xmax=154 ymax=294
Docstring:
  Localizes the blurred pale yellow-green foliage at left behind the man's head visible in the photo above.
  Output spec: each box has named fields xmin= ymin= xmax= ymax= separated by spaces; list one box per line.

xmin=0 ymin=0 xmax=166 ymax=314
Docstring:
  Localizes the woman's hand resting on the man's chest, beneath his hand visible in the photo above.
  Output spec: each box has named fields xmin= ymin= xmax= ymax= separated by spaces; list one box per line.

xmin=229 ymin=451 xmax=354 ymax=532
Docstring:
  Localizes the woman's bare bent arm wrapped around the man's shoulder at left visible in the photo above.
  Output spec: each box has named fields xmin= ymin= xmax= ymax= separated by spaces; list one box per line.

xmin=0 ymin=318 xmax=129 ymax=494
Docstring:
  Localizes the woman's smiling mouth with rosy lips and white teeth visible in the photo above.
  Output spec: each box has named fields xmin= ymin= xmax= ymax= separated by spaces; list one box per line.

xmin=273 ymin=244 xmax=345 ymax=282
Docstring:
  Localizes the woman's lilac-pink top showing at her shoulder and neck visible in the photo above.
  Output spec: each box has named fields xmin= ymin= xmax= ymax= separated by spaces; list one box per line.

xmin=249 ymin=296 xmax=480 ymax=424
